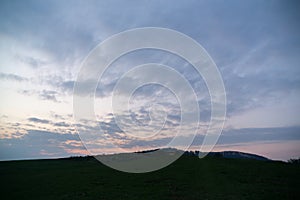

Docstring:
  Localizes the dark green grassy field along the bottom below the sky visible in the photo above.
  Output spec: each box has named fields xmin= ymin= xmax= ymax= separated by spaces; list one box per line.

xmin=0 ymin=156 xmax=300 ymax=200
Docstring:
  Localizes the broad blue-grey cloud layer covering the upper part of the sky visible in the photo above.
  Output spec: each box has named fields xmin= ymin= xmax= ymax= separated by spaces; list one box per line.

xmin=2 ymin=1 xmax=299 ymax=120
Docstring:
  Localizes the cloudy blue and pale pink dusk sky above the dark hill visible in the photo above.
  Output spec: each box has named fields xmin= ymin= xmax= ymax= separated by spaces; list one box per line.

xmin=0 ymin=0 xmax=300 ymax=160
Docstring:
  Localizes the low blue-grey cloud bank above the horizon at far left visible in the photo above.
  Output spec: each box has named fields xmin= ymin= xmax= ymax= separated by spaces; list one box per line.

xmin=0 ymin=130 xmax=87 ymax=160
